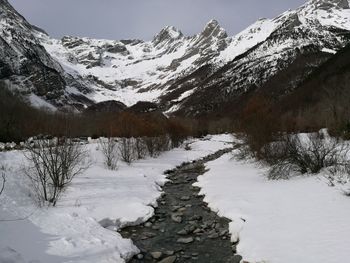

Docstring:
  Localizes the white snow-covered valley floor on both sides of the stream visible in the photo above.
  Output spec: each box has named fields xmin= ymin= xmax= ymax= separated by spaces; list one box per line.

xmin=0 ymin=135 xmax=350 ymax=263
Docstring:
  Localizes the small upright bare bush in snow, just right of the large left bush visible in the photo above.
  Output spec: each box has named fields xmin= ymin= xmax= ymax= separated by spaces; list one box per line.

xmin=99 ymin=137 xmax=118 ymax=170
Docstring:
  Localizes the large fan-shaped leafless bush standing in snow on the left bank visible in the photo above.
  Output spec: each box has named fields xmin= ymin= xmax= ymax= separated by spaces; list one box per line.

xmin=24 ymin=138 xmax=89 ymax=205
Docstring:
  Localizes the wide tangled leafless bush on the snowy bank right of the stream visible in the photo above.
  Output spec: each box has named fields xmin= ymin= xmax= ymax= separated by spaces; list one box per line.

xmin=265 ymin=133 xmax=350 ymax=179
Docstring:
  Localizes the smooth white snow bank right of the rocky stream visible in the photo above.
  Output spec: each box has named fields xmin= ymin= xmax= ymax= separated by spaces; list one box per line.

xmin=195 ymin=151 xmax=350 ymax=263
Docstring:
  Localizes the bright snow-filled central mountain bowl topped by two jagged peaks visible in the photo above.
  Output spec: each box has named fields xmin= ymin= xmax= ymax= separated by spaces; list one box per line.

xmin=37 ymin=20 xmax=232 ymax=106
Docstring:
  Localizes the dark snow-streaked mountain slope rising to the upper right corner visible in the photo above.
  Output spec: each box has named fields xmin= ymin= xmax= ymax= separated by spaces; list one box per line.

xmin=163 ymin=0 xmax=350 ymax=116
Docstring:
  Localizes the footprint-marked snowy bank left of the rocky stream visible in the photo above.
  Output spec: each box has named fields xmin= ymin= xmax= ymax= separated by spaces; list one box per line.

xmin=0 ymin=135 xmax=232 ymax=263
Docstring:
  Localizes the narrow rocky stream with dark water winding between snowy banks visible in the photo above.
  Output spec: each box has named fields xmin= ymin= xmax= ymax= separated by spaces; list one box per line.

xmin=120 ymin=148 xmax=242 ymax=263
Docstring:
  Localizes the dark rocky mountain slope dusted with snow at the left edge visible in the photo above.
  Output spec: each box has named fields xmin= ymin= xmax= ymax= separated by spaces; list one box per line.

xmin=0 ymin=0 xmax=91 ymax=110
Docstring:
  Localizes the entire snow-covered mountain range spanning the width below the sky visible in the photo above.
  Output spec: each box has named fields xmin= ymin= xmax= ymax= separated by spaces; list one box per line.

xmin=0 ymin=0 xmax=350 ymax=116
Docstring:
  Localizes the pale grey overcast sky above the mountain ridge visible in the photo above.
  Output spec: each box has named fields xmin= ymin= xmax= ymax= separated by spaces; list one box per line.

xmin=9 ymin=0 xmax=306 ymax=40
